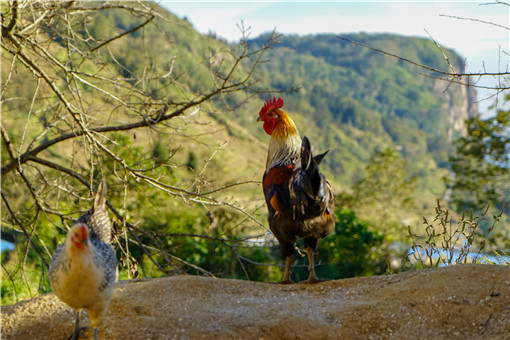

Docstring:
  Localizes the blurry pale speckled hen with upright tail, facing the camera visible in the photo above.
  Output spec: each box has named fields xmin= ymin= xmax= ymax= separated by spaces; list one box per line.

xmin=50 ymin=178 xmax=117 ymax=340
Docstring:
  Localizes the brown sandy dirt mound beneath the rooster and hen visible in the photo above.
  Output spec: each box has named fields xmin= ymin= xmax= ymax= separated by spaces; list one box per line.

xmin=1 ymin=265 xmax=510 ymax=340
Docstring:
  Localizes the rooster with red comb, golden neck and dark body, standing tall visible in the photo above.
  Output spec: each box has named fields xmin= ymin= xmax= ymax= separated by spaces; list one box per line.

xmin=257 ymin=97 xmax=335 ymax=283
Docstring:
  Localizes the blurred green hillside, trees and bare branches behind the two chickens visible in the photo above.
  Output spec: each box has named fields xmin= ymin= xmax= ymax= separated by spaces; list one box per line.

xmin=1 ymin=1 xmax=510 ymax=304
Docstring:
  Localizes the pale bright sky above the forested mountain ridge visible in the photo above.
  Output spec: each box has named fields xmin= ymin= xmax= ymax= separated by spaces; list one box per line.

xmin=160 ymin=1 xmax=510 ymax=111
